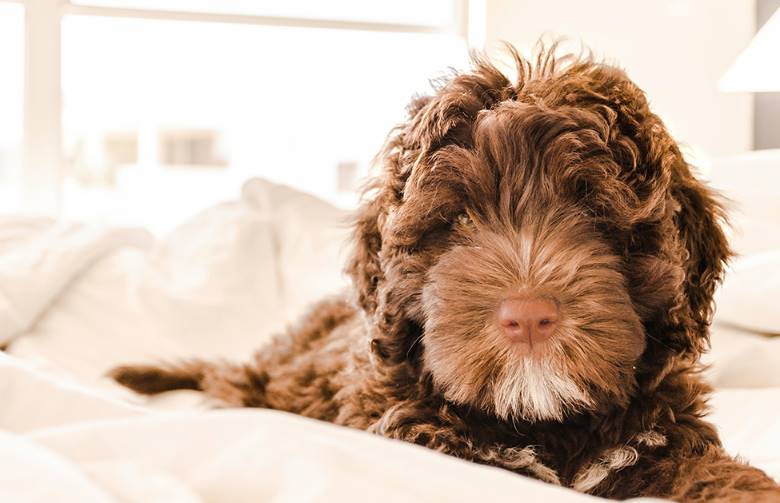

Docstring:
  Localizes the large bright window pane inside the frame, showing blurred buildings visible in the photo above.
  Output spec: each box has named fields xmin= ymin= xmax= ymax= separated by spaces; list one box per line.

xmin=62 ymin=13 xmax=466 ymax=228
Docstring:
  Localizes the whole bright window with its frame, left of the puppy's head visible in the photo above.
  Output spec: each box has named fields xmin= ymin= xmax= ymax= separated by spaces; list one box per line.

xmin=0 ymin=0 xmax=468 ymax=232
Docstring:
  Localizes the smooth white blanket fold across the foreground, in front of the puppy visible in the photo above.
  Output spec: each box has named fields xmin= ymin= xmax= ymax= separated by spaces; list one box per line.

xmin=0 ymin=354 xmax=620 ymax=503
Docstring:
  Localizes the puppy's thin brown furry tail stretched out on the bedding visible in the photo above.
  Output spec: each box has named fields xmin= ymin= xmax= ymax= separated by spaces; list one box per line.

xmin=109 ymin=360 xmax=267 ymax=407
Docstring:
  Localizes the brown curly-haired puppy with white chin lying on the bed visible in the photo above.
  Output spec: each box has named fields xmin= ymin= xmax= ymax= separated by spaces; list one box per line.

xmin=112 ymin=49 xmax=780 ymax=502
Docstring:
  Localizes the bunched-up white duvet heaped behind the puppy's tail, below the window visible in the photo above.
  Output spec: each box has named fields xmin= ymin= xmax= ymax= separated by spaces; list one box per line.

xmin=10 ymin=180 xmax=347 ymax=383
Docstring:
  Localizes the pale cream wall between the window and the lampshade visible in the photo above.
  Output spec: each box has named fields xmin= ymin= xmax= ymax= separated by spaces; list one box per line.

xmin=485 ymin=0 xmax=756 ymax=159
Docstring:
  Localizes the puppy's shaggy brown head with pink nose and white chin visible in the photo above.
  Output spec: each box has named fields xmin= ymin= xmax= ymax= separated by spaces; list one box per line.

xmin=348 ymin=51 xmax=729 ymax=421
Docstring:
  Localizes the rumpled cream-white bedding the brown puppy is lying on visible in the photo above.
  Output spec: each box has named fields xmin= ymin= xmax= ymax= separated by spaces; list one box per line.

xmin=0 ymin=175 xmax=780 ymax=502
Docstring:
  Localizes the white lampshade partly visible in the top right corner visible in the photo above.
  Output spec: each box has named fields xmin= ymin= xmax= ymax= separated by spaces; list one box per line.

xmin=718 ymin=9 xmax=780 ymax=93
